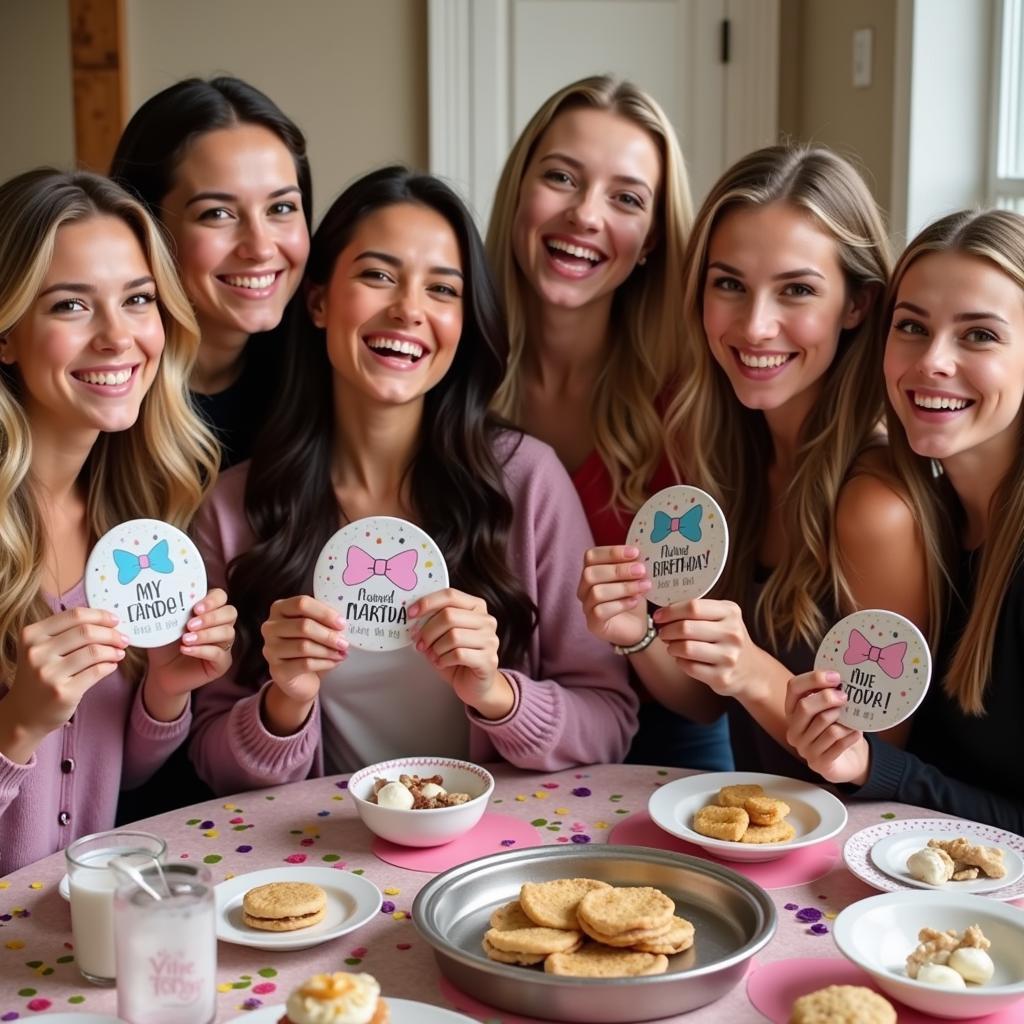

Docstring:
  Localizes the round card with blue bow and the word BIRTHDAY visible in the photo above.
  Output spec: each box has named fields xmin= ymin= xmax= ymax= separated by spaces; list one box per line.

xmin=626 ymin=484 xmax=729 ymax=605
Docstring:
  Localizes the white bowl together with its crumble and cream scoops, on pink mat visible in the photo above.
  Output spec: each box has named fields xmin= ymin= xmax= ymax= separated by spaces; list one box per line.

xmin=348 ymin=758 xmax=495 ymax=846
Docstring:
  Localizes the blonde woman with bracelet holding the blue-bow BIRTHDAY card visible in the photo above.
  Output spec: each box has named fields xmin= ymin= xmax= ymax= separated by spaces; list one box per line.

xmin=580 ymin=146 xmax=929 ymax=775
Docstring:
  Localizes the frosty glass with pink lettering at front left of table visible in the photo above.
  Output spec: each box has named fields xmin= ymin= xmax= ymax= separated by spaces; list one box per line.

xmin=114 ymin=863 xmax=217 ymax=1024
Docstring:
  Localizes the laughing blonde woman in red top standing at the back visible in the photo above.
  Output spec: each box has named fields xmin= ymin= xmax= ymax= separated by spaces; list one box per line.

xmin=487 ymin=75 xmax=728 ymax=768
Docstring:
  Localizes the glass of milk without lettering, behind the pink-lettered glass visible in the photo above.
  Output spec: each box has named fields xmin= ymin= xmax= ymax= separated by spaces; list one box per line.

xmin=65 ymin=829 xmax=167 ymax=985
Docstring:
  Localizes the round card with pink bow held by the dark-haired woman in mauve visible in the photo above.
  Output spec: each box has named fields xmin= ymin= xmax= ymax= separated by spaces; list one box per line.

xmin=313 ymin=516 xmax=449 ymax=650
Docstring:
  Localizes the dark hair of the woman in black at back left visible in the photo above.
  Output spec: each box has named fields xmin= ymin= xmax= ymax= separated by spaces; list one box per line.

xmin=110 ymin=76 xmax=313 ymax=228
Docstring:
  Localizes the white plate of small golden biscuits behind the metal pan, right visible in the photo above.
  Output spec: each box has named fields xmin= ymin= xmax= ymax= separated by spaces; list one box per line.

xmin=647 ymin=771 xmax=847 ymax=862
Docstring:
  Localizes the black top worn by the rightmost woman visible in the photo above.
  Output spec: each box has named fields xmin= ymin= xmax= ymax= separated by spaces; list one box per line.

xmin=853 ymin=552 xmax=1024 ymax=834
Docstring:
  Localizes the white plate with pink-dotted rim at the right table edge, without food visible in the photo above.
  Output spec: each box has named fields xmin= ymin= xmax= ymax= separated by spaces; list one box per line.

xmin=843 ymin=818 xmax=1024 ymax=900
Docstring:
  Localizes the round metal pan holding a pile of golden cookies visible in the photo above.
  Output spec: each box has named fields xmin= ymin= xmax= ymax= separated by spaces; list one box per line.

xmin=413 ymin=846 xmax=777 ymax=1024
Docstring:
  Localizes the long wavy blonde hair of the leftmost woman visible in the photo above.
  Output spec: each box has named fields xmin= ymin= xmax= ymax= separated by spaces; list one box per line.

xmin=0 ymin=168 xmax=218 ymax=682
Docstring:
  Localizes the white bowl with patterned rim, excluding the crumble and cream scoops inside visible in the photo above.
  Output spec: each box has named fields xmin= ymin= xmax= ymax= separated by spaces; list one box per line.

xmin=348 ymin=758 xmax=495 ymax=846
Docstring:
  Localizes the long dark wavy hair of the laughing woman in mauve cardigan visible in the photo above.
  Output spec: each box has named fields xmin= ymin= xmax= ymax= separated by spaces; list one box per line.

xmin=228 ymin=167 xmax=537 ymax=679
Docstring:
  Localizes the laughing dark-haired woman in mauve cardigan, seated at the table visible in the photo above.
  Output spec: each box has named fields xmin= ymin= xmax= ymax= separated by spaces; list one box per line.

xmin=193 ymin=168 xmax=636 ymax=793
